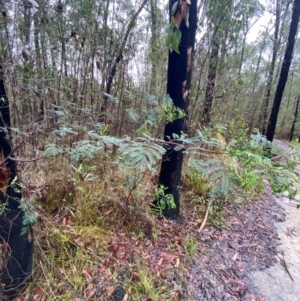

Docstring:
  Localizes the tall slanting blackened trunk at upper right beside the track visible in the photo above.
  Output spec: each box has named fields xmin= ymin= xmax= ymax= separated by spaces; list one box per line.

xmin=266 ymin=0 xmax=300 ymax=142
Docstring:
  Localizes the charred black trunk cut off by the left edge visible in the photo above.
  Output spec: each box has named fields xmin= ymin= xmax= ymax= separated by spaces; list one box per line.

xmin=0 ymin=66 xmax=33 ymax=300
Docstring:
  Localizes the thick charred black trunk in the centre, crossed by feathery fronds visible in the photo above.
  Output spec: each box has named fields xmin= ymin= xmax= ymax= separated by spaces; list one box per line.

xmin=154 ymin=0 xmax=197 ymax=219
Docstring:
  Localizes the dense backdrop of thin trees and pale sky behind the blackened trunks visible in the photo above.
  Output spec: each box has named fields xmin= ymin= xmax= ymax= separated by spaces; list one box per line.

xmin=1 ymin=0 xmax=299 ymax=139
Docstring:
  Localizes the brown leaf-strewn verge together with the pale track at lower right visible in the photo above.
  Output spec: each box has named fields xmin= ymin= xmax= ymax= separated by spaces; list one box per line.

xmin=186 ymin=141 xmax=300 ymax=301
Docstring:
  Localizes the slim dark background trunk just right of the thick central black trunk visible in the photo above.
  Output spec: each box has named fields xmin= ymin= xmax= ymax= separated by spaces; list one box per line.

xmin=202 ymin=38 xmax=220 ymax=126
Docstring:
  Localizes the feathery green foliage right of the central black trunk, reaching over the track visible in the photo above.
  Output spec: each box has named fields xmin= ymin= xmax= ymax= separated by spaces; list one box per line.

xmin=186 ymin=130 xmax=300 ymax=204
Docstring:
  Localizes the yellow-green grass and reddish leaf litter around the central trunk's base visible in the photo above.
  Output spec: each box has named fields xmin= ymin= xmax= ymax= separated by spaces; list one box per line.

xmin=14 ymin=137 xmax=266 ymax=301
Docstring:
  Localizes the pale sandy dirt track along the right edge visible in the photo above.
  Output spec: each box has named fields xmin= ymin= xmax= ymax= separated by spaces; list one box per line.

xmin=250 ymin=140 xmax=300 ymax=301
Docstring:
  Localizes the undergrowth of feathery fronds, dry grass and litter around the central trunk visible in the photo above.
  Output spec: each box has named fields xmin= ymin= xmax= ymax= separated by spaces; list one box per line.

xmin=12 ymin=117 xmax=299 ymax=301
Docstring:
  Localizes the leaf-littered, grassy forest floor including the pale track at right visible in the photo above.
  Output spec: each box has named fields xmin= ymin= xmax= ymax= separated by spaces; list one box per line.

xmin=17 ymin=141 xmax=300 ymax=301
